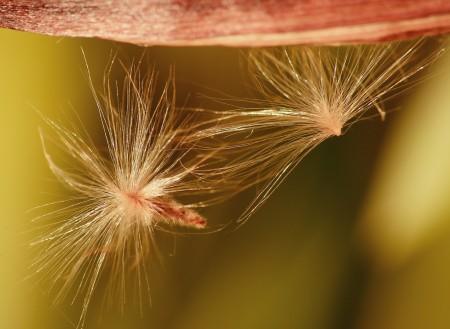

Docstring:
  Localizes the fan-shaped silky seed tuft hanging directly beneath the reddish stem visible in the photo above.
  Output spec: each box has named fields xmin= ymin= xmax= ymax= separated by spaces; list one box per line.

xmin=194 ymin=39 xmax=443 ymax=222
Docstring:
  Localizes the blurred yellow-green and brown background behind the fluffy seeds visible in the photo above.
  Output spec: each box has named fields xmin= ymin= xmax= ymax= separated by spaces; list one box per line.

xmin=0 ymin=30 xmax=450 ymax=329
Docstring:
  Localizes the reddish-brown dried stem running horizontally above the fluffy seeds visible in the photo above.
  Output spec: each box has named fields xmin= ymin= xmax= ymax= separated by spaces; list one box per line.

xmin=0 ymin=0 xmax=450 ymax=46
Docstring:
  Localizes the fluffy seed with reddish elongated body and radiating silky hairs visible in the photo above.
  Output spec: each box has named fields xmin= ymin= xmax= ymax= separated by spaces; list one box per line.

xmin=33 ymin=60 xmax=221 ymax=327
